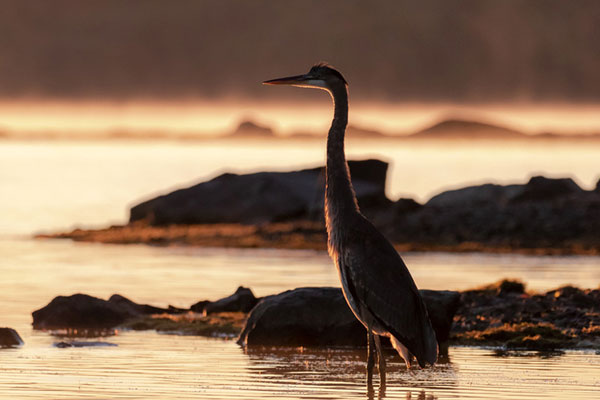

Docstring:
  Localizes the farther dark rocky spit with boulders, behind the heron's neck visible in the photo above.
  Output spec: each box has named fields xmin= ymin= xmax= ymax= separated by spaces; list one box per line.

xmin=39 ymin=160 xmax=600 ymax=255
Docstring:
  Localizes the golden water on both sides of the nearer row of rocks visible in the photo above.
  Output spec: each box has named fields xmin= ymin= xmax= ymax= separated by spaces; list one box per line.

xmin=0 ymin=240 xmax=600 ymax=399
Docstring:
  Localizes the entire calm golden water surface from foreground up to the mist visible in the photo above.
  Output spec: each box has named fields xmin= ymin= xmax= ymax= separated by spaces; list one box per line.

xmin=0 ymin=142 xmax=600 ymax=399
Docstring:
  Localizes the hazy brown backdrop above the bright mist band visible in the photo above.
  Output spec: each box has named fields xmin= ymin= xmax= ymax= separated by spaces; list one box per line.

xmin=0 ymin=0 xmax=600 ymax=103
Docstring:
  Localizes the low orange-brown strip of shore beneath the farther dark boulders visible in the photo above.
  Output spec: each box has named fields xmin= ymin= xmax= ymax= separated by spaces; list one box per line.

xmin=35 ymin=221 xmax=600 ymax=256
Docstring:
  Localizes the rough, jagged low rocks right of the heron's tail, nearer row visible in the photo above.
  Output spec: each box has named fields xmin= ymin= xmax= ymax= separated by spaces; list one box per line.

xmin=452 ymin=281 xmax=600 ymax=350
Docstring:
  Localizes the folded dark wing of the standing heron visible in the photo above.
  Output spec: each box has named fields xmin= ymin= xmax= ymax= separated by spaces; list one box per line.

xmin=339 ymin=216 xmax=437 ymax=366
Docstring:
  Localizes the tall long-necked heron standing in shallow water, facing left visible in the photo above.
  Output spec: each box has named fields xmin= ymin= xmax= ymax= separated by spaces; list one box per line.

xmin=264 ymin=63 xmax=438 ymax=385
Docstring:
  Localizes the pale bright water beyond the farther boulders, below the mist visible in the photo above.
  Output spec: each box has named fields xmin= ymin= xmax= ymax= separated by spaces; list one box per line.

xmin=0 ymin=140 xmax=600 ymax=235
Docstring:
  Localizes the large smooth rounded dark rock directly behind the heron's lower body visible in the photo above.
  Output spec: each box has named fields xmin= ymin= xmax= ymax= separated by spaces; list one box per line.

xmin=238 ymin=287 xmax=459 ymax=346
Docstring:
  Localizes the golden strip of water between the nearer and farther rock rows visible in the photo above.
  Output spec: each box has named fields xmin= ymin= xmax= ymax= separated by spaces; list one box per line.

xmin=0 ymin=239 xmax=600 ymax=328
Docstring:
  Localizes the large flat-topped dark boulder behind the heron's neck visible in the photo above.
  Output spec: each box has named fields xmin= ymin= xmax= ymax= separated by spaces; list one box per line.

xmin=129 ymin=160 xmax=390 ymax=225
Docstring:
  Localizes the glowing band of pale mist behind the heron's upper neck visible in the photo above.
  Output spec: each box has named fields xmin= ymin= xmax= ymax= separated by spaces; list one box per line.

xmin=0 ymin=101 xmax=600 ymax=139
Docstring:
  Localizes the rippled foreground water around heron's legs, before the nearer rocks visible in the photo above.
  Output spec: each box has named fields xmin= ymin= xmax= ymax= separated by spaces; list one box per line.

xmin=0 ymin=333 xmax=600 ymax=399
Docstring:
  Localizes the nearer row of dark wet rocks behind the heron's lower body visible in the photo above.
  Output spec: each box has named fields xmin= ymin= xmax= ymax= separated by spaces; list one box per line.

xmin=33 ymin=280 xmax=600 ymax=351
